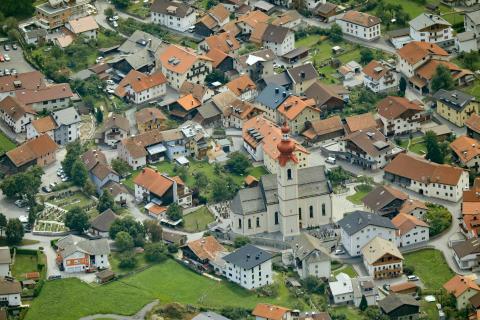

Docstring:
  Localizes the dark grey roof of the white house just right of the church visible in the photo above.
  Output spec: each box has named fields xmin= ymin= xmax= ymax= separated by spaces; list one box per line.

xmin=338 ymin=210 xmax=396 ymax=235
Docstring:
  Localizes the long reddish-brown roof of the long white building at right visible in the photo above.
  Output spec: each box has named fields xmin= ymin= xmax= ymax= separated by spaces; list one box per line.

xmin=384 ymin=153 xmax=464 ymax=186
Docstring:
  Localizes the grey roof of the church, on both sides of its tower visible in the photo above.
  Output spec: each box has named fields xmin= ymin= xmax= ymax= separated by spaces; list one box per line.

xmin=230 ymin=166 xmax=331 ymax=215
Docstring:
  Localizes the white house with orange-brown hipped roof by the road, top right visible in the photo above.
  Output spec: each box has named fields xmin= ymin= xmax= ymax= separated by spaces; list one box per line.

xmin=336 ymin=10 xmax=381 ymax=41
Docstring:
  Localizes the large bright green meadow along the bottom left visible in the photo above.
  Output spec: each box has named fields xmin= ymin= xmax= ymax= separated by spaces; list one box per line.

xmin=25 ymin=260 xmax=299 ymax=320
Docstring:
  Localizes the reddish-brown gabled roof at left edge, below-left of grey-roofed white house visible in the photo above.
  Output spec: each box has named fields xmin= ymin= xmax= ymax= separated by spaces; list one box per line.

xmin=6 ymin=134 xmax=58 ymax=167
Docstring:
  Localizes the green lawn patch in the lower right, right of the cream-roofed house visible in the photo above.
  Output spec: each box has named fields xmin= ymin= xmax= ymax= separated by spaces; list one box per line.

xmin=404 ymin=249 xmax=455 ymax=289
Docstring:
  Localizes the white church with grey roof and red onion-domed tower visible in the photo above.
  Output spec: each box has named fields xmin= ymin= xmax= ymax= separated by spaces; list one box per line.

xmin=230 ymin=126 xmax=332 ymax=240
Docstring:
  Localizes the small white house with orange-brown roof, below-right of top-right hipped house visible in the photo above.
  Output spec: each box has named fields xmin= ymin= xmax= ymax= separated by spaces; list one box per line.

xmin=362 ymin=60 xmax=400 ymax=93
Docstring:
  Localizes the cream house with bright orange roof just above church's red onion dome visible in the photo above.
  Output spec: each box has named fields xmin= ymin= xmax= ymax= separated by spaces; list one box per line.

xmin=277 ymin=95 xmax=321 ymax=134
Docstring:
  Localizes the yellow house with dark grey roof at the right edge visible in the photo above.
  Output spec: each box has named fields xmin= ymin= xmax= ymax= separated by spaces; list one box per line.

xmin=433 ymin=89 xmax=480 ymax=127
